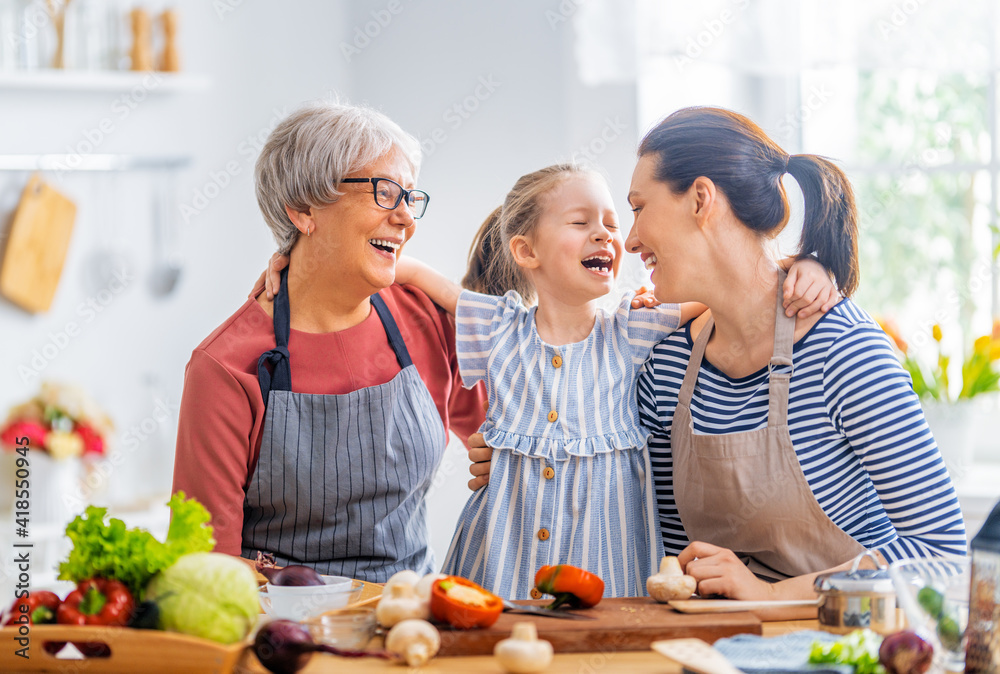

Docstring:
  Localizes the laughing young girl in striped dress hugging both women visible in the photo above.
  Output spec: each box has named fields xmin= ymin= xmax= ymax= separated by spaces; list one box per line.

xmin=396 ymin=164 xmax=832 ymax=599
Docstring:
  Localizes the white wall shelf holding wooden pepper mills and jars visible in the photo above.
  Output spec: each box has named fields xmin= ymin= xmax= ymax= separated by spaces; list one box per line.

xmin=0 ymin=69 xmax=211 ymax=94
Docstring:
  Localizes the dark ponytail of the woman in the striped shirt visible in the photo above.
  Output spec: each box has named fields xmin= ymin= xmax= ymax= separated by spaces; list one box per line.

xmin=788 ymin=154 xmax=860 ymax=297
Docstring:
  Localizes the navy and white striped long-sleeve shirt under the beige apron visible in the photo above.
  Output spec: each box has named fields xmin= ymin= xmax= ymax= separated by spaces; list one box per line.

xmin=639 ymin=300 xmax=966 ymax=560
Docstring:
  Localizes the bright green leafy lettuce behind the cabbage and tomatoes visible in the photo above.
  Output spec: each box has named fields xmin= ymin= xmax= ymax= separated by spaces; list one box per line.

xmin=59 ymin=491 xmax=215 ymax=597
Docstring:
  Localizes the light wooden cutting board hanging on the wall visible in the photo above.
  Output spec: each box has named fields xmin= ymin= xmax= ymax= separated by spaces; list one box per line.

xmin=0 ymin=174 xmax=76 ymax=313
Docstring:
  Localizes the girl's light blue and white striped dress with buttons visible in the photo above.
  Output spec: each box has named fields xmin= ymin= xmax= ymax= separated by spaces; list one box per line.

xmin=444 ymin=291 xmax=680 ymax=599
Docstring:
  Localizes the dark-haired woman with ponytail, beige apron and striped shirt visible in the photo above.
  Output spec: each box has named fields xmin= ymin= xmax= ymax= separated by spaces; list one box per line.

xmin=626 ymin=108 xmax=966 ymax=599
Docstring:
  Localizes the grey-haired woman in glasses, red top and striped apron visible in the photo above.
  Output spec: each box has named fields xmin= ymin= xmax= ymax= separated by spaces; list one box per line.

xmin=174 ymin=104 xmax=485 ymax=582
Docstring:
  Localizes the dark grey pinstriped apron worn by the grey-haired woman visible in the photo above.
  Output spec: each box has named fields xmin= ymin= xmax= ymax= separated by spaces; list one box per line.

xmin=241 ymin=270 xmax=447 ymax=583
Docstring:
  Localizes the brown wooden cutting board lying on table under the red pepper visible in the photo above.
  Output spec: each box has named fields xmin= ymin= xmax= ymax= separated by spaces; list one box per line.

xmin=439 ymin=597 xmax=761 ymax=656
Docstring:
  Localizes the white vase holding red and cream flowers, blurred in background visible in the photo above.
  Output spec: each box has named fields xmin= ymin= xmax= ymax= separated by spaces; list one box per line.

xmin=28 ymin=451 xmax=83 ymax=527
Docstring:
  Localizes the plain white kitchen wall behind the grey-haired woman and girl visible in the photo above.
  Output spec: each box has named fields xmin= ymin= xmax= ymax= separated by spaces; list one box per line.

xmin=0 ymin=0 xmax=638 ymax=559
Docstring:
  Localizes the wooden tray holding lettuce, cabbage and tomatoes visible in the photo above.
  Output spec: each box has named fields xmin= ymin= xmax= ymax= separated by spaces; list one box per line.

xmin=0 ymin=625 xmax=250 ymax=674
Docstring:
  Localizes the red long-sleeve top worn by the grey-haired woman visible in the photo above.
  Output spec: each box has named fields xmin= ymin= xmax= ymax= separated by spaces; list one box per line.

xmin=173 ymin=284 xmax=486 ymax=555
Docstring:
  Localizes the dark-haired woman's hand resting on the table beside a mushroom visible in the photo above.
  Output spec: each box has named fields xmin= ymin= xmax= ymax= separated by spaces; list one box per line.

xmin=677 ymin=541 xmax=774 ymax=601
